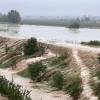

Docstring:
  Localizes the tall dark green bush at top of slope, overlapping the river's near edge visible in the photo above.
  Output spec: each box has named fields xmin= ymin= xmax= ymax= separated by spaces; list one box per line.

xmin=24 ymin=38 xmax=38 ymax=56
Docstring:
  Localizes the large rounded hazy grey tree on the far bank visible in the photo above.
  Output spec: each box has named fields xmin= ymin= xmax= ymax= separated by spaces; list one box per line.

xmin=7 ymin=10 xmax=21 ymax=23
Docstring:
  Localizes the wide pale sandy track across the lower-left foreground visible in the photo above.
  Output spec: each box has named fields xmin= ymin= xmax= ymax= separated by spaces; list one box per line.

xmin=0 ymin=69 xmax=71 ymax=100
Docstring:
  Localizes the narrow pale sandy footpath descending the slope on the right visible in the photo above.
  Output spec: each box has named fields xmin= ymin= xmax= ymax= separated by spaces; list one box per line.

xmin=73 ymin=50 xmax=98 ymax=100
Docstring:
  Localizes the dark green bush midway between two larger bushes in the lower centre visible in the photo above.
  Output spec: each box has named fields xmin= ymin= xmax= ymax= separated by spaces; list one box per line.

xmin=52 ymin=71 xmax=64 ymax=90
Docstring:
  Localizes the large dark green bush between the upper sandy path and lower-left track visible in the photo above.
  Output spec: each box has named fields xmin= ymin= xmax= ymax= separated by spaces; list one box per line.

xmin=28 ymin=62 xmax=46 ymax=82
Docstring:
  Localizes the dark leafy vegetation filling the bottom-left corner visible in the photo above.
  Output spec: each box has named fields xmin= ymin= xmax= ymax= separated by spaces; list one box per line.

xmin=0 ymin=76 xmax=31 ymax=100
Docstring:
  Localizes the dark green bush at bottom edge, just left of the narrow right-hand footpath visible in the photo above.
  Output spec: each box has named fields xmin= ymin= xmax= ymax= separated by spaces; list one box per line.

xmin=65 ymin=77 xmax=82 ymax=99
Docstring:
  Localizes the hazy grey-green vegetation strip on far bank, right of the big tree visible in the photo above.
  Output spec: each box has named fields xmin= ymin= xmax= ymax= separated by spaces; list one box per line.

xmin=21 ymin=17 xmax=100 ymax=28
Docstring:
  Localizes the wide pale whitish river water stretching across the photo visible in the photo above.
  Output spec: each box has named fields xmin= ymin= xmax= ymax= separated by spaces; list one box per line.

xmin=0 ymin=24 xmax=100 ymax=42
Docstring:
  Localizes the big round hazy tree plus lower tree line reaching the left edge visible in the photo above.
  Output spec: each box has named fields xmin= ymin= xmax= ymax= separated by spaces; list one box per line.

xmin=0 ymin=10 xmax=21 ymax=23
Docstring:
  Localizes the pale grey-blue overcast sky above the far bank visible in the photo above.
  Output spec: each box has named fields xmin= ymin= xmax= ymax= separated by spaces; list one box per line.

xmin=0 ymin=0 xmax=100 ymax=16
